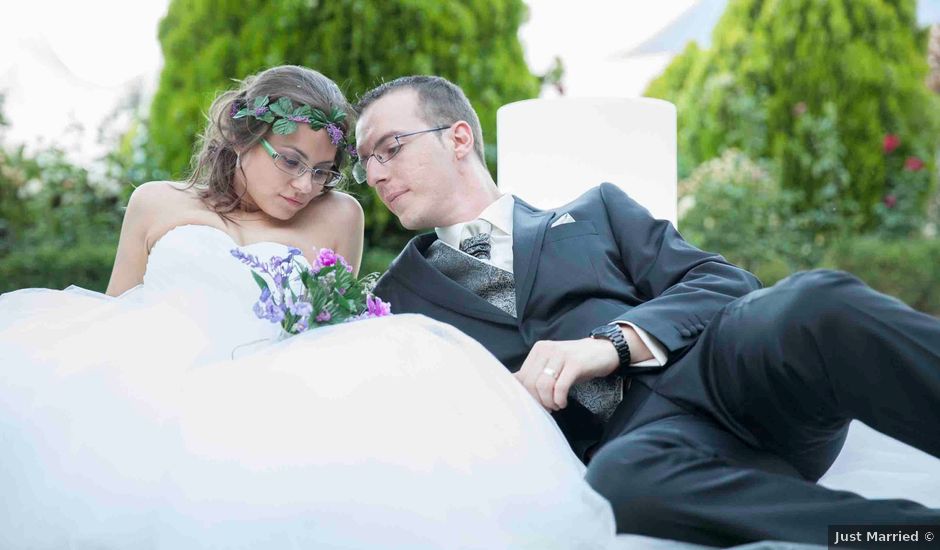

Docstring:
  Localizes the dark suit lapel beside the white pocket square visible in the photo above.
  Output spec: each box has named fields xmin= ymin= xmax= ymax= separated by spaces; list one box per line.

xmin=512 ymin=197 xmax=552 ymax=319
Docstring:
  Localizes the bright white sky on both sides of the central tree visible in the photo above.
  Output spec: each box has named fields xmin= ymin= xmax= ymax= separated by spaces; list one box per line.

xmin=0 ymin=0 xmax=696 ymax=163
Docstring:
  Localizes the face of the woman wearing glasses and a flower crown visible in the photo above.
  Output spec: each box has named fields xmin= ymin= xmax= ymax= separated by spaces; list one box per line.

xmin=235 ymin=124 xmax=336 ymax=220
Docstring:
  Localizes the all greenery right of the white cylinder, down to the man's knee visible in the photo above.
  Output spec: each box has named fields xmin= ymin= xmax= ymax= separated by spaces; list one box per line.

xmin=647 ymin=0 xmax=940 ymax=314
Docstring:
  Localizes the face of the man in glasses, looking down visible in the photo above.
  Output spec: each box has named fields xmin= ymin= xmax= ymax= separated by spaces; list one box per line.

xmin=356 ymin=89 xmax=461 ymax=229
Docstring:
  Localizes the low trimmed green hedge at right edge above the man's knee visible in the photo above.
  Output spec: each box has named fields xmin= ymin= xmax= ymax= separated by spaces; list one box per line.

xmin=823 ymin=237 xmax=940 ymax=316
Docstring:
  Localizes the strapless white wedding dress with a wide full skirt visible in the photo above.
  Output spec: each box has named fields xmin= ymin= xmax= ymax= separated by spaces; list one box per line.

xmin=0 ymin=225 xmax=614 ymax=550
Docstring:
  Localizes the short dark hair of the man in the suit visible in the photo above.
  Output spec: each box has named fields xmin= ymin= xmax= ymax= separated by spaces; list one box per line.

xmin=356 ymin=75 xmax=486 ymax=166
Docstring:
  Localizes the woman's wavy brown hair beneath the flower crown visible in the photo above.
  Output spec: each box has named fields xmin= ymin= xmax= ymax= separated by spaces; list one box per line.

xmin=187 ymin=65 xmax=355 ymax=219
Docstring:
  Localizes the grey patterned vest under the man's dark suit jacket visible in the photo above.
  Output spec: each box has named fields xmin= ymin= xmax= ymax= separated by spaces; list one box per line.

xmin=426 ymin=241 xmax=623 ymax=422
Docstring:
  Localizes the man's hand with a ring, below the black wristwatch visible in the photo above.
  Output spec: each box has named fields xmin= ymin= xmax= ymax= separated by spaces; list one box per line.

xmin=514 ymin=338 xmax=620 ymax=411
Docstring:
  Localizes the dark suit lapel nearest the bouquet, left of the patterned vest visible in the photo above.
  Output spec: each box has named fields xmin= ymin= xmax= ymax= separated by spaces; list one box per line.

xmin=389 ymin=233 xmax=516 ymax=326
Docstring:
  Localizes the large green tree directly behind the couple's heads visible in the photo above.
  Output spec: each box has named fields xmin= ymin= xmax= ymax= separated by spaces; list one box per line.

xmin=149 ymin=0 xmax=539 ymax=252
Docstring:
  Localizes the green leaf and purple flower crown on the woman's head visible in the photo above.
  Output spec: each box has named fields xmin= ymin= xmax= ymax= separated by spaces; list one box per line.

xmin=231 ymin=96 xmax=356 ymax=157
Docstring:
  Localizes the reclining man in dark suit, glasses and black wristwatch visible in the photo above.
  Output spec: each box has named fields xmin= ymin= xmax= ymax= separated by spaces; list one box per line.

xmin=354 ymin=76 xmax=940 ymax=546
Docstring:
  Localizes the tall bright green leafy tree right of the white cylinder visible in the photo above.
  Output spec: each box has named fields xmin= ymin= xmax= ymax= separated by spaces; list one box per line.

xmin=647 ymin=0 xmax=938 ymax=229
